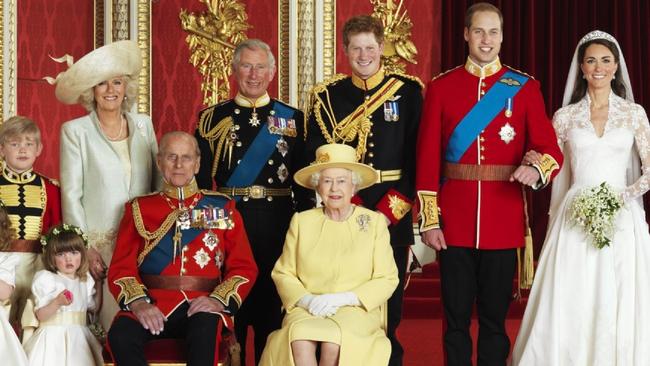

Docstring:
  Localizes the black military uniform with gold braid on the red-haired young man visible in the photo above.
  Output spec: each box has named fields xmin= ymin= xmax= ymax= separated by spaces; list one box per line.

xmin=299 ymin=69 xmax=423 ymax=365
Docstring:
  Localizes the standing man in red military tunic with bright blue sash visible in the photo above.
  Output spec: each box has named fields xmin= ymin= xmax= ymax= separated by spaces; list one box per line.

xmin=416 ymin=3 xmax=562 ymax=366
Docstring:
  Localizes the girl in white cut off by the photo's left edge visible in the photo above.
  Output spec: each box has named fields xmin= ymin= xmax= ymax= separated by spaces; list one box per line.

xmin=0 ymin=201 xmax=27 ymax=366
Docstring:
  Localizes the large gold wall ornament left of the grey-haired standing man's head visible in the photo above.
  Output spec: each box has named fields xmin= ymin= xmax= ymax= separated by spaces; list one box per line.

xmin=179 ymin=0 xmax=251 ymax=105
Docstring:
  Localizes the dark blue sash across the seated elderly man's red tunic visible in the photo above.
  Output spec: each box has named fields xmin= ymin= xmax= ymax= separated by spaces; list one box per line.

xmin=139 ymin=196 xmax=226 ymax=275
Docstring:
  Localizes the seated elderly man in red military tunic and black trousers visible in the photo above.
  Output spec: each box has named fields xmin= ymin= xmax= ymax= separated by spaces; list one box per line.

xmin=108 ymin=132 xmax=257 ymax=366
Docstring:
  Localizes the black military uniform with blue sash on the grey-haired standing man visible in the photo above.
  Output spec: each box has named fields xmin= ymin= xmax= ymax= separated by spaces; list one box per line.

xmin=195 ymin=95 xmax=304 ymax=364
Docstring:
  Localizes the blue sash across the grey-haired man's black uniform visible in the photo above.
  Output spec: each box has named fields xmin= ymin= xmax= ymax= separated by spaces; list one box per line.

xmin=226 ymin=102 xmax=294 ymax=201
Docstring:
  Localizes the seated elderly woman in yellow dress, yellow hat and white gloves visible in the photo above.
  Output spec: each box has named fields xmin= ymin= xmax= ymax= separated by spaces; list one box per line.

xmin=260 ymin=144 xmax=398 ymax=366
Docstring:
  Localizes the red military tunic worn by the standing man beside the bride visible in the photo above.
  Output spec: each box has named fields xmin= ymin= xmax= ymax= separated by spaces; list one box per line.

xmin=416 ymin=58 xmax=562 ymax=249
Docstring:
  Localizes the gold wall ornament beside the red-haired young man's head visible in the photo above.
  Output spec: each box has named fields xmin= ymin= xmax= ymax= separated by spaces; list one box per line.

xmin=370 ymin=0 xmax=418 ymax=73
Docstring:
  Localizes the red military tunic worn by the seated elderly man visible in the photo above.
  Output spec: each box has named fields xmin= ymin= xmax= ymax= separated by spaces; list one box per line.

xmin=108 ymin=182 xmax=257 ymax=327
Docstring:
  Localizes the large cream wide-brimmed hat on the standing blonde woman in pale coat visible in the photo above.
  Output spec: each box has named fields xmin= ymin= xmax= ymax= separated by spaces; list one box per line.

xmin=52 ymin=41 xmax=142 ymax=104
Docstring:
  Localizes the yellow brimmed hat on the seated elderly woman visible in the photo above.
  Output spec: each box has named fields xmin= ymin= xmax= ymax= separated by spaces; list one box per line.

xmin=293 ymin=144 xmax=379 ymax=189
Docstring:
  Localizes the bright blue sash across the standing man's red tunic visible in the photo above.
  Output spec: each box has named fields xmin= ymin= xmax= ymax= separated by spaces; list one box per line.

xmin=445 ymin=71 xmax=529 ymax=163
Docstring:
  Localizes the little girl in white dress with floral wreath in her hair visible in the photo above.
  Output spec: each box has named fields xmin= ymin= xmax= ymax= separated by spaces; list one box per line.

xmin=24 ymin=224 xmax=103 ymax=366
